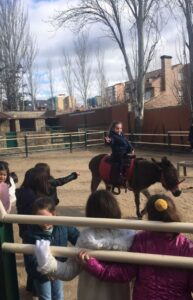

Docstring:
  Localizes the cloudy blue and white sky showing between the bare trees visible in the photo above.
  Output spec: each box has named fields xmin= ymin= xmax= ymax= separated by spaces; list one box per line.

xmin=26 ymin=0 xmax=185 ymax=100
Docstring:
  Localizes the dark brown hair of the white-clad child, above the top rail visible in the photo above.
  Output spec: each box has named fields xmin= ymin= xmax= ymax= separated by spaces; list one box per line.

xmin=86 ymin=190 xmax=121 ymax=219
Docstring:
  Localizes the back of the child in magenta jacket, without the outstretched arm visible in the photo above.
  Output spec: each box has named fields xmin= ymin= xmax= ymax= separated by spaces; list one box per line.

xmin=132 ymin=232 xmax=193 ymax=300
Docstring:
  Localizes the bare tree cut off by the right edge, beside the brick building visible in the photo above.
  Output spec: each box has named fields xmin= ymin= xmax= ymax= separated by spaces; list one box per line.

xmin=177 ymin=0 xmax=193 ymax=118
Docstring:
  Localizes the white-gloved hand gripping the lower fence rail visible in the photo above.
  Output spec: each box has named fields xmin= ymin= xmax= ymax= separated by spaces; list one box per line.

xmin=35 ymin=240 xmax=50 ymax=268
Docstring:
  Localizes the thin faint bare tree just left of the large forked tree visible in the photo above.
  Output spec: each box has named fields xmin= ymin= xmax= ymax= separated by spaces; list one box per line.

xmin=96 ymin=45 xmax=107 ymax=106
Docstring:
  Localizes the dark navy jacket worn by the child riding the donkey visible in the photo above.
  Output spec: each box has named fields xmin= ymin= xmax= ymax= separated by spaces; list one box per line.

xmin=109 ymin=131 xmax=133 ymax=157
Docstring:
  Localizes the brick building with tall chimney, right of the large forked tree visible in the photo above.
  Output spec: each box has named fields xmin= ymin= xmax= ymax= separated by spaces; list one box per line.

xmin=125 ymin=55 xmax=189 ymax=109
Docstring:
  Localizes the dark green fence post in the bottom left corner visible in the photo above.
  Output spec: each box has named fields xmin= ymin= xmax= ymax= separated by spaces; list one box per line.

xmin=0 ymin=223 xmax=19 ymax=300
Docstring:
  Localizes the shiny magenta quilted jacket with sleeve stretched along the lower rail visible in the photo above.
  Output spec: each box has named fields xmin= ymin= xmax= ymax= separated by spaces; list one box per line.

xmin=86 ymin=232 xmax=193 ymax=300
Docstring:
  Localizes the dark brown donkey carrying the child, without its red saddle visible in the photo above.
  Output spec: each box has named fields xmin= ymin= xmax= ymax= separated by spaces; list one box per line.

xmin=89 ymin=154 xmax=181 ymax=218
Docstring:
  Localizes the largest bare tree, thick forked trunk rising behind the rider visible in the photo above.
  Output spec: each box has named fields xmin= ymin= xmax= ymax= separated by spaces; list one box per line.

xmin=54 ymin=0 xmax=164 ymax=130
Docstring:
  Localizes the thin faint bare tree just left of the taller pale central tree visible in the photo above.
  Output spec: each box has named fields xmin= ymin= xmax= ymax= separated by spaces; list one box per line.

xmin=60 ymin=49 xmax=74 ymax=97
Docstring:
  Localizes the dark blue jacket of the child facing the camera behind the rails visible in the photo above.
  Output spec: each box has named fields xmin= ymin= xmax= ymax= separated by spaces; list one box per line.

xmin=23 ymin=225 xmax=79 ymax=282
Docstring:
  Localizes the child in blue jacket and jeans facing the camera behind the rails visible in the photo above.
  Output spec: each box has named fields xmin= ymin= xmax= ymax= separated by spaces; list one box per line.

xmin=24 ymin=197 xmax=79 ymax=300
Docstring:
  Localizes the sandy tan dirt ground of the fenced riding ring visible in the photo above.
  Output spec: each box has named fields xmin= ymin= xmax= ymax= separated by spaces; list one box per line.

xmin=5 ymin=149 xmax=193 ymax=300
